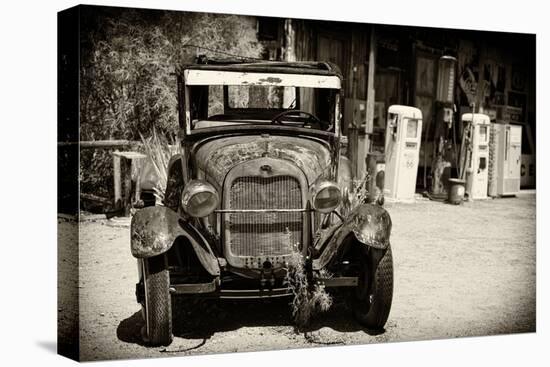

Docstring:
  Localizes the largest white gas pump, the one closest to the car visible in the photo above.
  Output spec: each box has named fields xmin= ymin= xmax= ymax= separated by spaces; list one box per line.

xmin=384 ymin=105 xmax=422 ymax=201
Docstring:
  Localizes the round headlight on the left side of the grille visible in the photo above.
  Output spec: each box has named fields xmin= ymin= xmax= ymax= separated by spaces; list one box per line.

xmin=181 ymin=180 xmax=220 ymax=218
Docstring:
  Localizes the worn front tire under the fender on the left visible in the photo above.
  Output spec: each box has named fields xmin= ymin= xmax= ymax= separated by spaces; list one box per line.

xmin=142 ymin=255 xmax=173 ymax=346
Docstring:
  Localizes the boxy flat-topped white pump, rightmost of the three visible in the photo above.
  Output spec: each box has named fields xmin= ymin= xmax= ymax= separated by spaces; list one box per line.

xmin=493 ymin=124 xmax=521 ymax=196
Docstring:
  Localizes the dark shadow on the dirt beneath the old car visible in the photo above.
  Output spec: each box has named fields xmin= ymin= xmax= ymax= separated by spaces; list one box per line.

xmin=117 ymin=299 xmax=384 ymax=351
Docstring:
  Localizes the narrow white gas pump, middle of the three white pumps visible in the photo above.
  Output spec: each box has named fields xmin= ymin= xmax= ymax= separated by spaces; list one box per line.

xmin=462 ymin=113 xmax=491 ymax=200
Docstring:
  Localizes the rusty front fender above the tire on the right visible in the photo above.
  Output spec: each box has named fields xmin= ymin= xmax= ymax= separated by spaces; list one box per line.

xmin=313 ymin=204 xmax=392 ymax=269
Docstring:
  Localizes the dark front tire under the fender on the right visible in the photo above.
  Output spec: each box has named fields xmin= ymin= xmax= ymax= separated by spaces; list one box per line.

xmin=352 ymin=247 xmax=393 ymax=330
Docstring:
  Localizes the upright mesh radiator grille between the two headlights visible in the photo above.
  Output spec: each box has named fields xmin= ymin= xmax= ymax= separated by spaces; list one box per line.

xmin=228 ymin=176 xmax=303 ymax=256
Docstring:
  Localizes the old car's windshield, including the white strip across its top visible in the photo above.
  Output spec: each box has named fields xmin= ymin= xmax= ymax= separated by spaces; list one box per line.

xmin=186 ymin=71 xmax=340 ymax=131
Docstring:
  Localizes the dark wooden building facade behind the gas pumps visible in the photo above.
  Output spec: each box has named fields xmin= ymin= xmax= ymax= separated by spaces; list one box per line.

xmin=258 ymin=17 xmax=536 ymax=189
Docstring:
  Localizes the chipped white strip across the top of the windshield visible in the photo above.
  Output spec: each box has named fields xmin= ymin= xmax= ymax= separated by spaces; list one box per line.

xmin=184 ymin=69 xmax=341 ymax=89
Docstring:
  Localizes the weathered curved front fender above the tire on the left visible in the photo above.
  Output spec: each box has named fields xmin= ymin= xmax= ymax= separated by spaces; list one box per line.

xmin=130 ymin=206 xmax=220 ymax=276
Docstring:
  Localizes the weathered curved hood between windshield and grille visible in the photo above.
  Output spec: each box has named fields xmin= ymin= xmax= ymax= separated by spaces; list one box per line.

xmin=195 ymin=135 xmax=331 ymax=186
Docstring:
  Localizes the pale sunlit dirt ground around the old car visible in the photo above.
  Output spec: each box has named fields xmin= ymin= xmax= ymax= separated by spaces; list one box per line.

xmin=58 ymin=193 xmax=536 ymax=360
